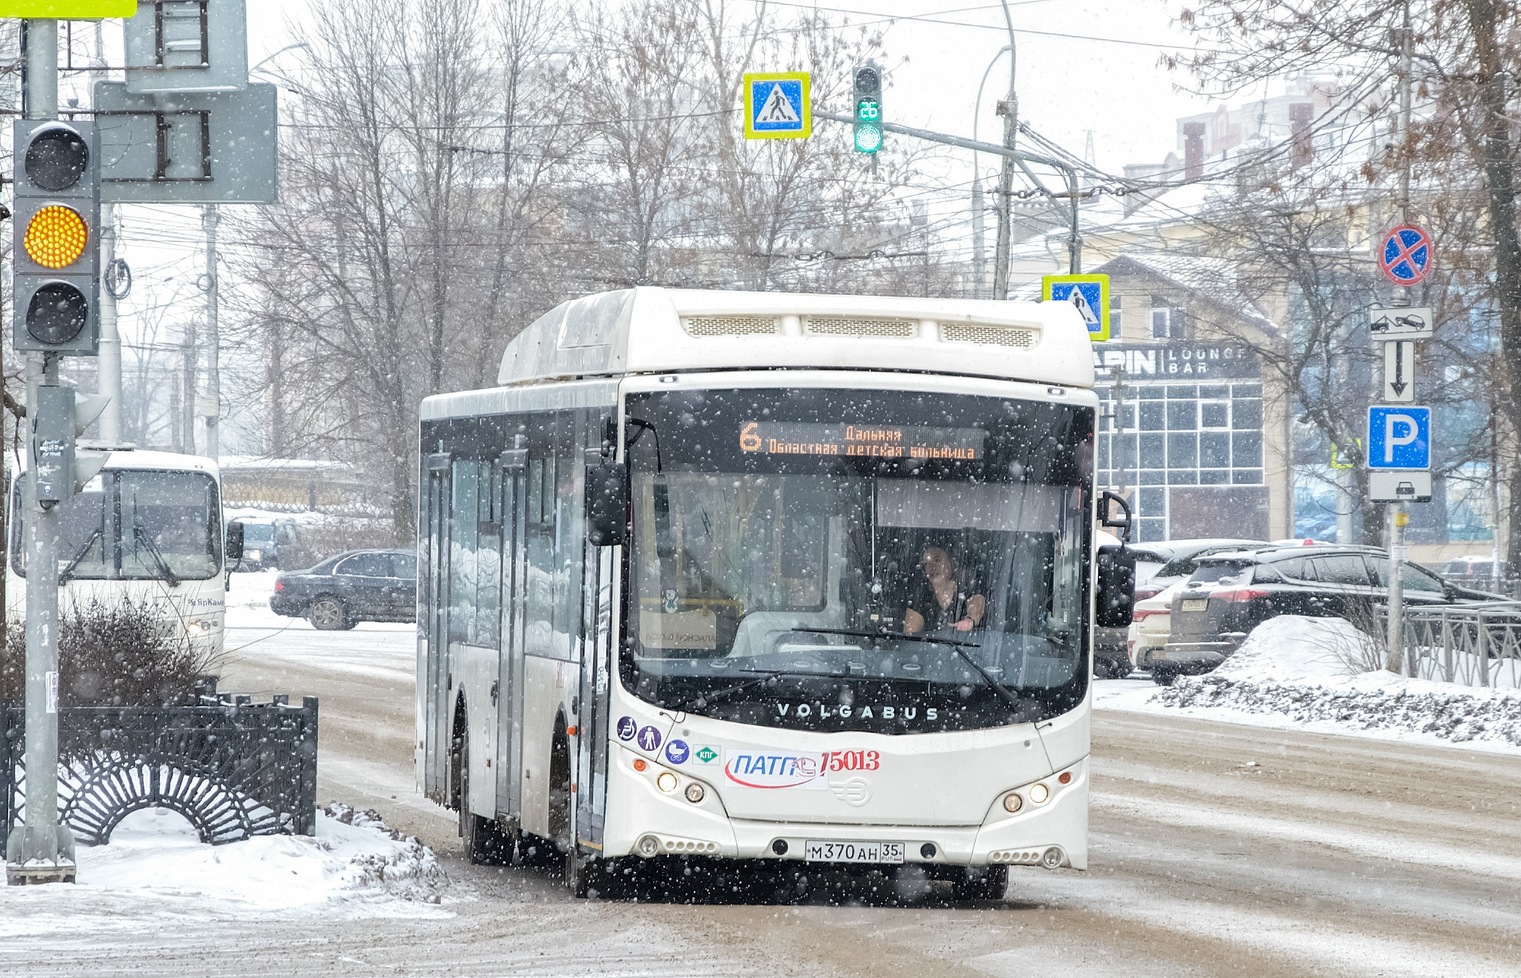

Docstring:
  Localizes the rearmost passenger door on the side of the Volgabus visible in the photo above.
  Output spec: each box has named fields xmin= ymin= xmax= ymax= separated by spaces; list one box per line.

xmin=417 ymin=455 xmax=452 ymax=805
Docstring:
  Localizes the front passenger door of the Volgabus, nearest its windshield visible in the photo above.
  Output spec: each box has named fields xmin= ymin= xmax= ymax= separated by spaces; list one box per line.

xmin=575 ymin=450 xmax=622 ymax=844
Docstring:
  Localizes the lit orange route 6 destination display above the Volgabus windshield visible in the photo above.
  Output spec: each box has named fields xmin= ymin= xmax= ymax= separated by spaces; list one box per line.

xmin=739 ymin=421 xmax=987 ymax=461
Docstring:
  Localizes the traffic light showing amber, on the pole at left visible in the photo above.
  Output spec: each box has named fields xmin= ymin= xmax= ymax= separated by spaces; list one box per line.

xmin=11 ymin=119 xmax=100 ymax=356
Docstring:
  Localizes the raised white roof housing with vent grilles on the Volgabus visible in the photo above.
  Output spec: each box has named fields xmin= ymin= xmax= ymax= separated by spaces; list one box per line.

xmin=497 ymin=287 xmax=1094 ymax=388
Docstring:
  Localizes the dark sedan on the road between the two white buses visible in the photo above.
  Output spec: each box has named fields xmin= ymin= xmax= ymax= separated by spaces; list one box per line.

xmin=269 ymin=551 xmax=417 ymax=630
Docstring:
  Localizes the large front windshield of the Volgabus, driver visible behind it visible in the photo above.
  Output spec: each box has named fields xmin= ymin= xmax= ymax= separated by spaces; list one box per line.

xmin=621 ymin=388 xmax=1094 ymax=733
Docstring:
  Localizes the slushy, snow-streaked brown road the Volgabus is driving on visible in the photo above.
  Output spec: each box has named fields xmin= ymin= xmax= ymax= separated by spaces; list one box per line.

xmin=11 ymin=581 xmax=1521 ymax=978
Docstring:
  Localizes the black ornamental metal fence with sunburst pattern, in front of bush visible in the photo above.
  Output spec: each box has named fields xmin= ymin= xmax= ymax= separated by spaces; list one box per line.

xmin=0 ymin=694 xmax=316 ymax=846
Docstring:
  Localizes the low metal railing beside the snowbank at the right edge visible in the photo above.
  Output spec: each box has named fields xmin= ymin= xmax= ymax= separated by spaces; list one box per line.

xmin=1404 ymin=604 xmax=1521 ymax=687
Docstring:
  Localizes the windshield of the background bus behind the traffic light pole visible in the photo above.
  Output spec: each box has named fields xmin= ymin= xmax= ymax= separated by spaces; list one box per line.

xmin=11 ymin=468 xmax=222 ymax=584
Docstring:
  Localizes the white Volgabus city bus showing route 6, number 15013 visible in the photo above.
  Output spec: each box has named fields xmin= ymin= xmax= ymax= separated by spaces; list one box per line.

xmin=417 ymin=287 xmax=1132 ymax=897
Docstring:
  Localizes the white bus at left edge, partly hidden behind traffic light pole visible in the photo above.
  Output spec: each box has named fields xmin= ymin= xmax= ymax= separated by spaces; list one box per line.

xmin=6 ymin=449 xmax=236 ymax=660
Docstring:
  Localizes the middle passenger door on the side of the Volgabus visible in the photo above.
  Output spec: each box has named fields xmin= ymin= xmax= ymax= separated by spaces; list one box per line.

xmin=496 ymin=449 xmax=528 ymax=820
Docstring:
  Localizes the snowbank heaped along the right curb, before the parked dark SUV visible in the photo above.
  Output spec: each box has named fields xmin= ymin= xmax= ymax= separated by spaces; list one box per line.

xmin=1153 ymin=616 xmax=1521 ymax=747
